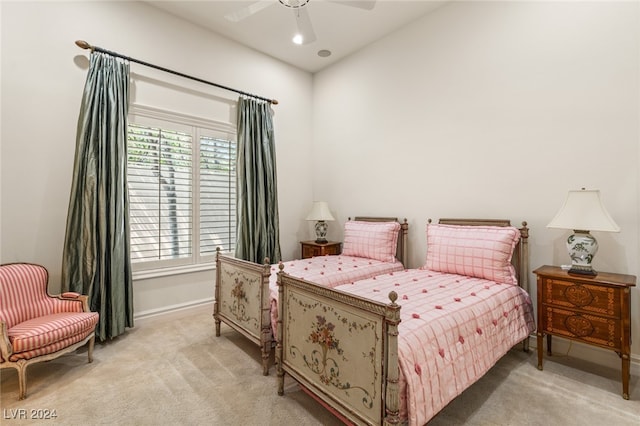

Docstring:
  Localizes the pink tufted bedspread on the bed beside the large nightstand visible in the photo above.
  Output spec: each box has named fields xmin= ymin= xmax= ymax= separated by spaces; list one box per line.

xmin=336 ymin=269 xmax=535 ymax=426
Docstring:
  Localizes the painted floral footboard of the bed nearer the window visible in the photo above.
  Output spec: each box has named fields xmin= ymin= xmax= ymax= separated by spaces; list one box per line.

xmin=213 ymin=251 xmax=271 ymax=375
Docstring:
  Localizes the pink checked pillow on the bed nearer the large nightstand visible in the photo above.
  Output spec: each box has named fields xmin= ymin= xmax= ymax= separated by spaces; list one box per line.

xmin=425 ymin=223 xmax=520 ymax=284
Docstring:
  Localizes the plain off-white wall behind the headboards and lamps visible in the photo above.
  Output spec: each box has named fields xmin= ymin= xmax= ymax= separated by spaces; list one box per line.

xmin=313 ymin=2 xmax=640 ymax=365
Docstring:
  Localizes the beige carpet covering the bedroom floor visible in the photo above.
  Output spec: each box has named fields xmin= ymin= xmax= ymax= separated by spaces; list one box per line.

xmin=0 ymin=307 xmax=640 ymax=426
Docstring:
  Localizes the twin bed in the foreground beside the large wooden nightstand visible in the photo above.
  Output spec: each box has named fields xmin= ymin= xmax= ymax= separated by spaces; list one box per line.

xmin=276 ymin=219 xmax=535 ymax=426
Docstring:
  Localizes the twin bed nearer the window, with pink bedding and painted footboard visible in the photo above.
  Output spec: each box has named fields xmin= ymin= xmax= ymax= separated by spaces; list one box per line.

xmin=213 ymin=217 xmax=409 ymax=375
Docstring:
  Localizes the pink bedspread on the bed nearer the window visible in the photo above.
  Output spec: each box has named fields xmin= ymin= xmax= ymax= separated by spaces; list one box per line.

xmin=269 ymin=255 xmax=404 ymax=339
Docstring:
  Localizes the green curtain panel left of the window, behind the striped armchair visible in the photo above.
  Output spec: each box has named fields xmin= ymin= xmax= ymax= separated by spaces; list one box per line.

xmin=62 ymin=52 xmax=133 ymax=340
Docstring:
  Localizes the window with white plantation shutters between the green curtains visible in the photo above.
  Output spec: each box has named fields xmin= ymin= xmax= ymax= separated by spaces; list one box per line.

xmin=127 ymin=107 xmax=236 ymax=270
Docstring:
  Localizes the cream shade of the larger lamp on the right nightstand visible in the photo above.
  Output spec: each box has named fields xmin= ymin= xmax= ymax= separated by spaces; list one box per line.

xmin=547 ymin=189 xmax=620 ymax=232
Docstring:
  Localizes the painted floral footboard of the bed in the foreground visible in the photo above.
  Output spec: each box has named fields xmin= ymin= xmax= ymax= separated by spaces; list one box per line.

xmin=276 ymin=272 xmax=400 ymax=425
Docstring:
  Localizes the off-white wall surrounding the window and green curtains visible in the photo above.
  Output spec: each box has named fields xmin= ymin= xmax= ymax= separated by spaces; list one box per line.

xmin=0 ymin=2 xmax=312 ymax=316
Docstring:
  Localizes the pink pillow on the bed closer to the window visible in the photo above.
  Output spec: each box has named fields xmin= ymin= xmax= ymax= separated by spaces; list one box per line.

xmin=342 ymin=220 xmax=400 ymax=262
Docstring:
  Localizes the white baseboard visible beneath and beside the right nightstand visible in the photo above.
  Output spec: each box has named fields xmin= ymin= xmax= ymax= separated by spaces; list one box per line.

xmin=529 ymin=336 xmax=640 ymax=376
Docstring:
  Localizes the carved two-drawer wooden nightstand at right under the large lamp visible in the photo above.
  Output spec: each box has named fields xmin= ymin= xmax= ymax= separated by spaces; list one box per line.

xmin=533 ymin=265 xmax=636 ymax=399
